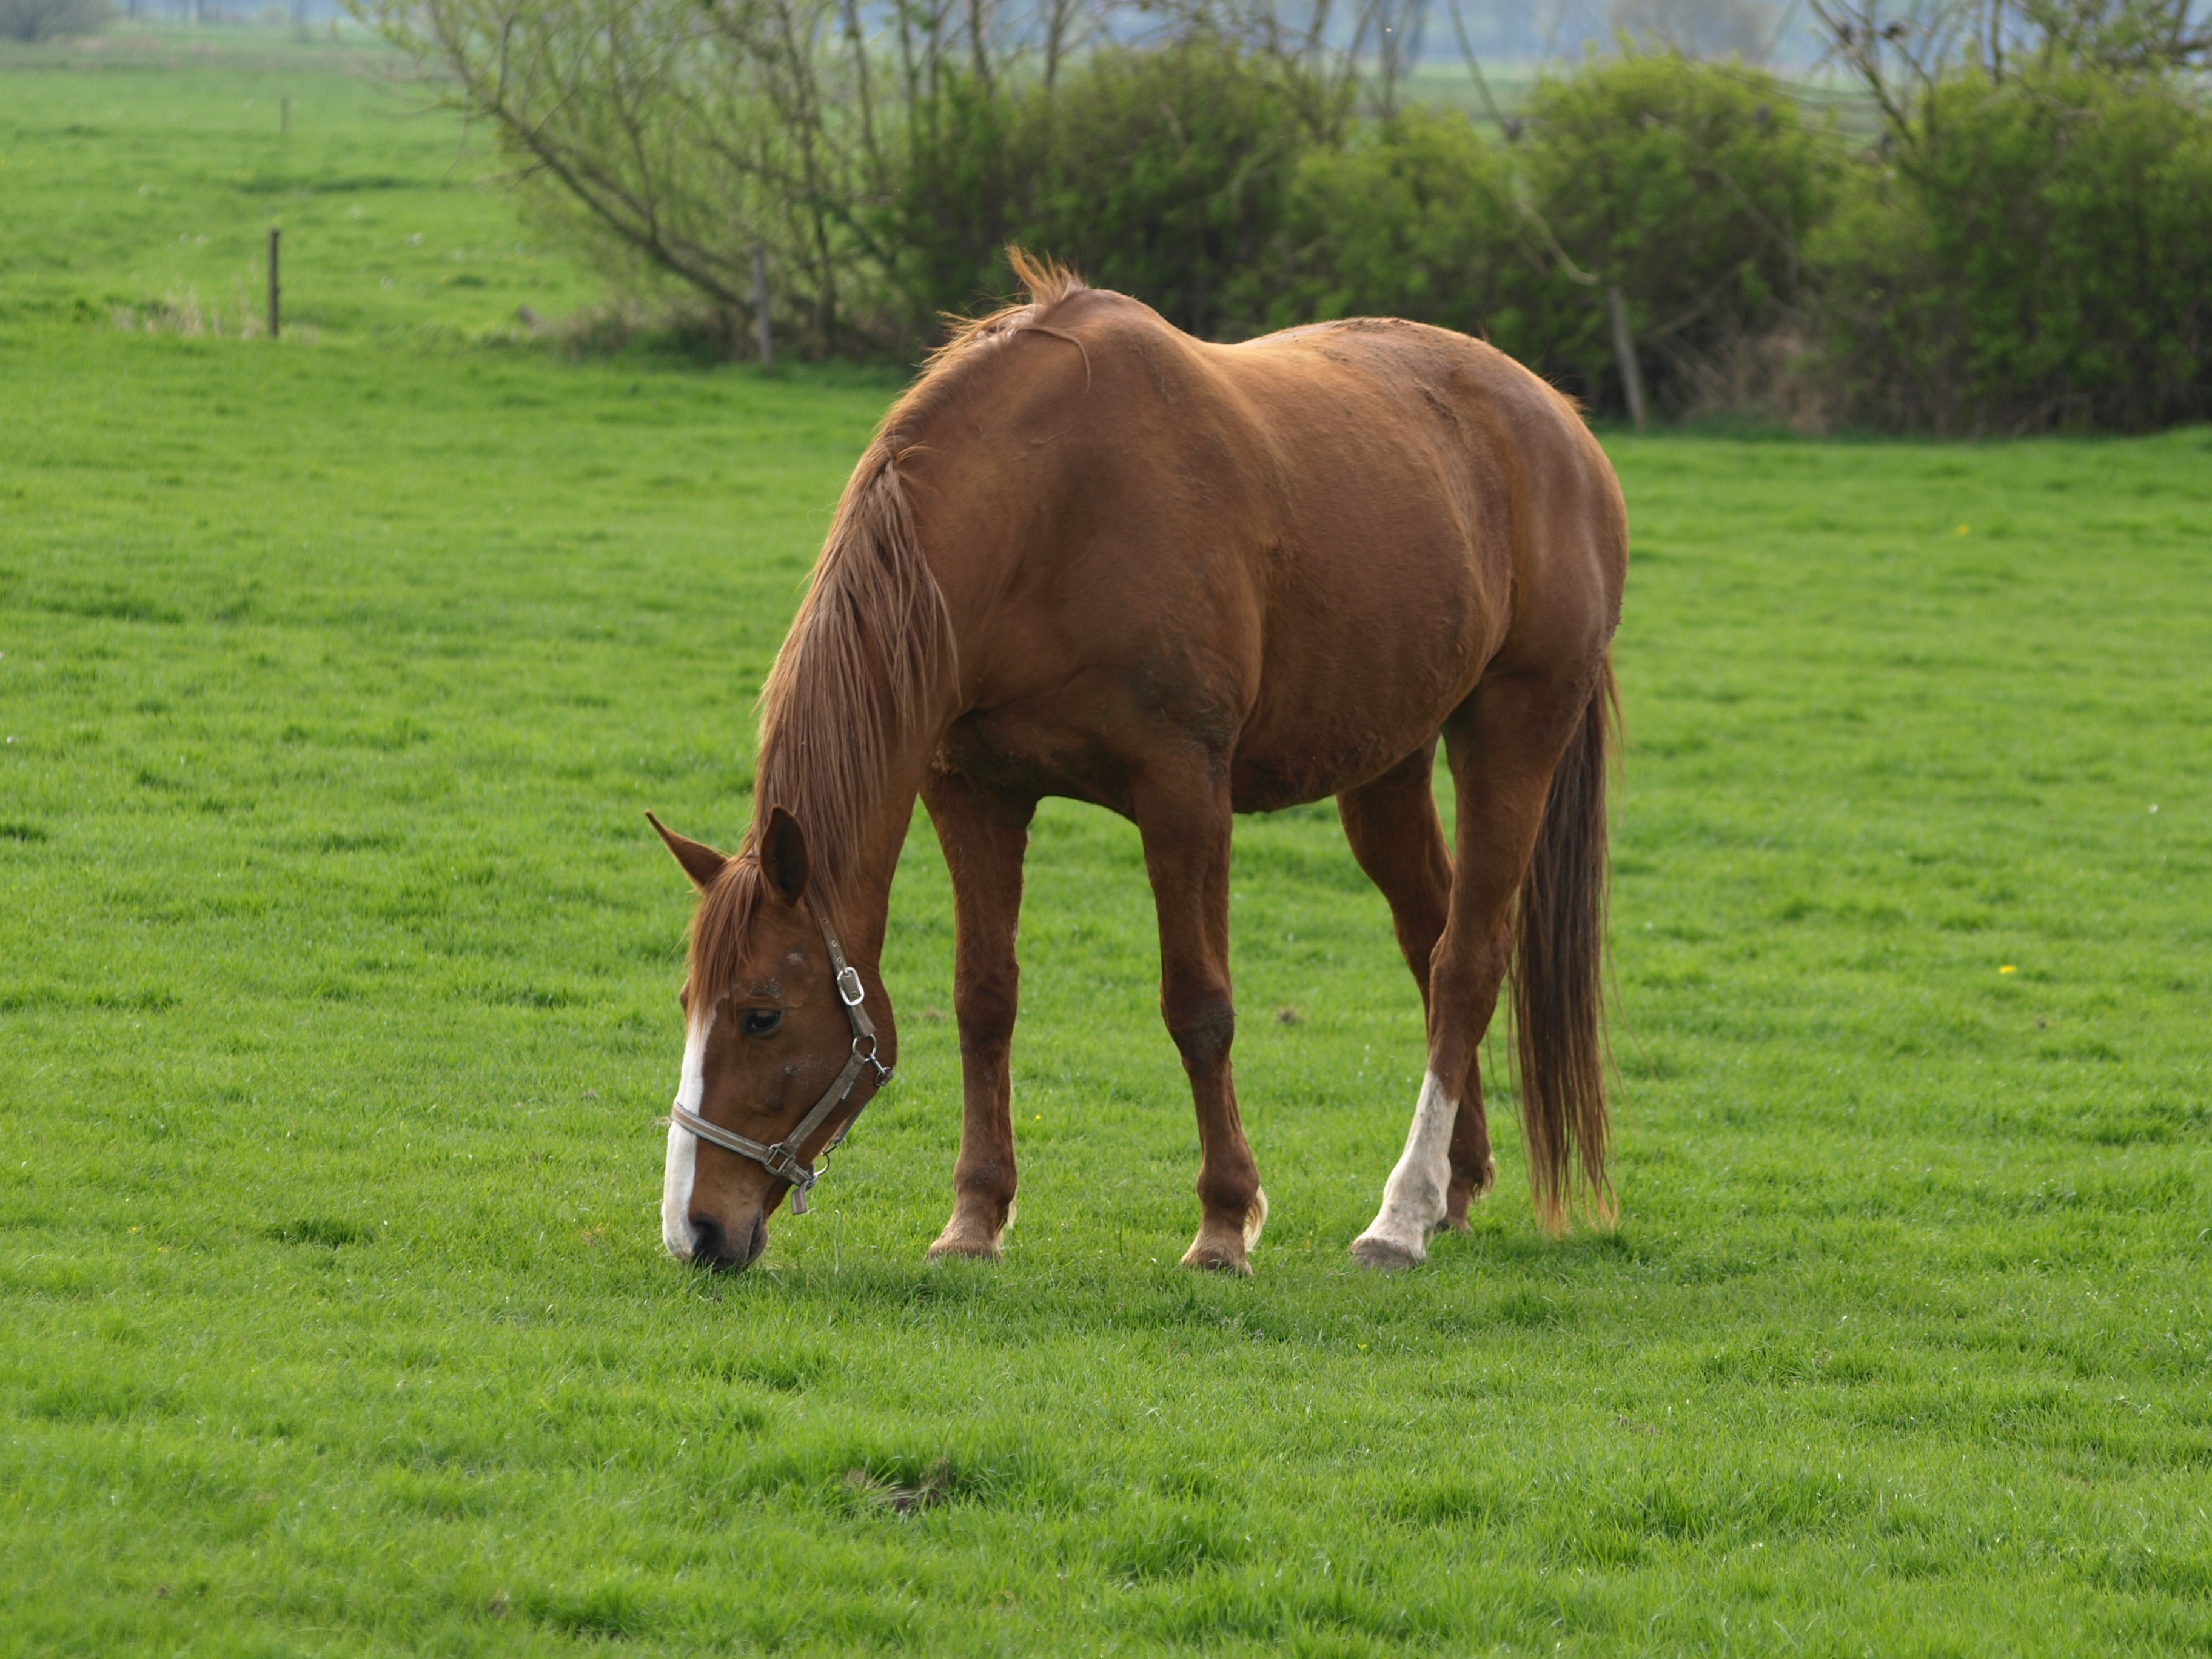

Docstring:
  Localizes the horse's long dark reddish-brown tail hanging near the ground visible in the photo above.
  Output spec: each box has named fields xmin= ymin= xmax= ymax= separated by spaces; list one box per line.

xmin=1513 ymin=657 xmax=1619 ymax=1235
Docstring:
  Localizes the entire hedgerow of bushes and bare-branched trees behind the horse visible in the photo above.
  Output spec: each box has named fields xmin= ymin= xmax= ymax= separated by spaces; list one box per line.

xmin=376 ymin=0 xmax=2212 ymax=434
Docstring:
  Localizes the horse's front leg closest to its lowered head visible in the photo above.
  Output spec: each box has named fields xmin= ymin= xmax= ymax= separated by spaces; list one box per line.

xmin=922 ymin=770 xmax=1037 ymax=1261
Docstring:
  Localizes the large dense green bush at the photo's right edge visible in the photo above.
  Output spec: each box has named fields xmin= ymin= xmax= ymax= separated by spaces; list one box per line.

xmin=1818 ymin=71 xmax=2212 ymax=431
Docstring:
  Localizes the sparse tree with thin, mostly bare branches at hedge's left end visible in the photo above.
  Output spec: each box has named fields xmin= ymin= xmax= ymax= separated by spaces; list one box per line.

xmin=354 ymin=0 xmax=924 ymax=352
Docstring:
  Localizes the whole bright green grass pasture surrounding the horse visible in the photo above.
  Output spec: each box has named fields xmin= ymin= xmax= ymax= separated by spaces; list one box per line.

xmin=13 ymin=42 xmax=2212 ymax=1655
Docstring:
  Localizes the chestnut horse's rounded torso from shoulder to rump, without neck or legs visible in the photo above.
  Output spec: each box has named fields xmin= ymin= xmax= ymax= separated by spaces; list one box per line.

xmin=902 ymin=292 xmax=1626 ymax=809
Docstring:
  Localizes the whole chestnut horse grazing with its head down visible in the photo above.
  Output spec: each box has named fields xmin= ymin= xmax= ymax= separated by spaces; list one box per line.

xmin=655 ymin=256 xmax=1628 ymax=1272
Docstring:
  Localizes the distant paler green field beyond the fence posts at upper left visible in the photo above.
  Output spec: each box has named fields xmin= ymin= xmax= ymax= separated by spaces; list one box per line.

xmin=0 ymin=28 xmax=595 ymax=345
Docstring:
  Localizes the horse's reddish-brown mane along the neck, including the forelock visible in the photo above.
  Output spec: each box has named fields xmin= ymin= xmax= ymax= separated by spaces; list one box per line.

xmin=690 ymin=248 xmax=1084 ymax=1007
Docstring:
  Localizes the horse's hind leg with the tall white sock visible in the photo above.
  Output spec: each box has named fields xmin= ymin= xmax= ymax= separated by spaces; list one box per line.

xmin=1352 ymin=679 xmax=1584 ymax=1270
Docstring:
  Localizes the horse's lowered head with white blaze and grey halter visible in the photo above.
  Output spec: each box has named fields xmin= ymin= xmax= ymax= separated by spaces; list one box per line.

xmin=646 ymin=808 xmax=891 ymax=1267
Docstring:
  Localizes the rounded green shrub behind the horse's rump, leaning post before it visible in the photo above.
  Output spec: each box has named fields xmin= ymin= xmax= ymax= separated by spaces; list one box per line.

xmin=1522 ymin=53 xmax=1845 ymax=409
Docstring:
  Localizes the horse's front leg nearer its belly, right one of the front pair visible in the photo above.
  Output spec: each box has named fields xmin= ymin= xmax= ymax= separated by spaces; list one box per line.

xmin=1134 ymin=776 xmax=1267 ymax=1274
